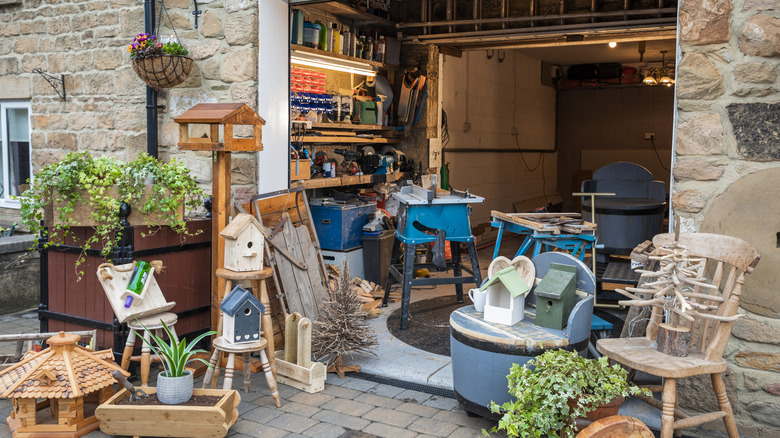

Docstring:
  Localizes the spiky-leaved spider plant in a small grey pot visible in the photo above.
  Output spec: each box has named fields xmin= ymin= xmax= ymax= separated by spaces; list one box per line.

xmin=136 ymin=319 xmax=217 ymax=405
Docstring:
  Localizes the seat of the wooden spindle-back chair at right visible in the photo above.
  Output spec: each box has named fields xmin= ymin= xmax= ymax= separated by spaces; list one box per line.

xmin=596 ymin=337 xmax=726 ymax=379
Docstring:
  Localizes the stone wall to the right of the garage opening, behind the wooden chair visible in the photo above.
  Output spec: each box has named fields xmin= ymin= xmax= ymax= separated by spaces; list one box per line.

xmin=672 ymin=0 xmax=780 ymax=437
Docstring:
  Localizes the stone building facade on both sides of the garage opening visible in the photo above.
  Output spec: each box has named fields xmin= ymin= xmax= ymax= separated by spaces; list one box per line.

xmin=0 ymin=0 xmax=780 ymax=438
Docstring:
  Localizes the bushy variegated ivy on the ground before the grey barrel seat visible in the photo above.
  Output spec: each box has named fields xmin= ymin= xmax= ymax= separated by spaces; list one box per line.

xmin=483 ymin=350 xmax=649 ymax=438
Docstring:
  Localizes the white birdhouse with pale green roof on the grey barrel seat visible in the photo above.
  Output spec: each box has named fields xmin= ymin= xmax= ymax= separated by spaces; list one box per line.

xmin=480 ymin=266 xmax=531 ymax=325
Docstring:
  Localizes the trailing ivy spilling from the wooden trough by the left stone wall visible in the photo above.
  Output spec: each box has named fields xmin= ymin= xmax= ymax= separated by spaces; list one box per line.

xmin=16 ymin=152 xmax=204 ymax=279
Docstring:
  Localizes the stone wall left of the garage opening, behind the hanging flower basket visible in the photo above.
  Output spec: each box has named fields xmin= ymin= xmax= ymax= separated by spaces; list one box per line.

xmin=0 ymin=0 xmax=257 ymax=221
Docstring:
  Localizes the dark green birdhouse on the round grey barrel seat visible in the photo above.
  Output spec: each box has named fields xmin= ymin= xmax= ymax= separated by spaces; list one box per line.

xmin=534 ymin=263 xmax=577 ymax=330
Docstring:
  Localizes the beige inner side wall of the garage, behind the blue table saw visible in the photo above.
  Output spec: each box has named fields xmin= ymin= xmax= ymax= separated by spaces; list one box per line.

xmin=441 ymin=51 xmax=557 ymax=225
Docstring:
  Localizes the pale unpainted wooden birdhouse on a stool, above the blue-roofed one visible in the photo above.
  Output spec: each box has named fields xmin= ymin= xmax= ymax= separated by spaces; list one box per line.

xmin=219 ymin=213 xmax=265 ymax=272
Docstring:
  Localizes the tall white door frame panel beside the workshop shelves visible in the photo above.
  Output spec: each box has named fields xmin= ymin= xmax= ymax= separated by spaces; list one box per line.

xmin=257 ymin=0 xmax=290 ymax=193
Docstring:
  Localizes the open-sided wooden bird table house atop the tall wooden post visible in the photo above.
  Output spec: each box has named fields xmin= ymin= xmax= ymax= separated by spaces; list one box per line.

xmin=173 ymin=103 xmax=265 ymax=152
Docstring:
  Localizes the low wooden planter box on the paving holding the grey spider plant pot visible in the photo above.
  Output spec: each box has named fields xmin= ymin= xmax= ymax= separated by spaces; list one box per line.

xmin=95 ymin=388 xmax=241 ymax=438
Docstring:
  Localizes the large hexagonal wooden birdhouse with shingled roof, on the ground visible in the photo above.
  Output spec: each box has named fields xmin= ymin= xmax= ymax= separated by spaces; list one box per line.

xmin=0 ymin=332 xmax=130 ymax=437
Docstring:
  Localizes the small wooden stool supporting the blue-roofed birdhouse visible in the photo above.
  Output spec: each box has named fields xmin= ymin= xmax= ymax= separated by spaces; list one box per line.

xmin=203 ymin=336 xmax=282 ymax=408
